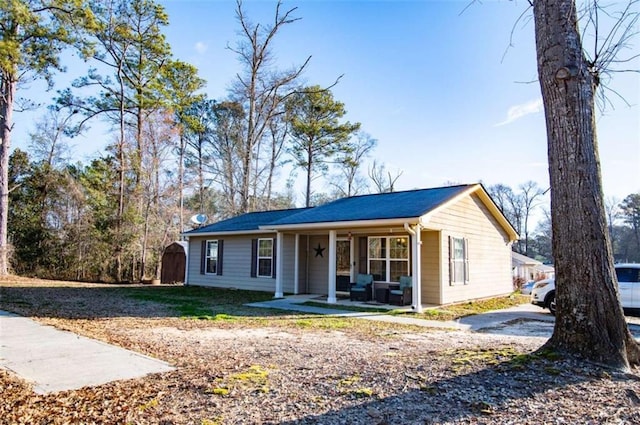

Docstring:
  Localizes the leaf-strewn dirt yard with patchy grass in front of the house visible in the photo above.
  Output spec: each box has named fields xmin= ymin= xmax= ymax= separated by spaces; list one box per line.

xmin=0 ymin=279 xmax=640 ymax=425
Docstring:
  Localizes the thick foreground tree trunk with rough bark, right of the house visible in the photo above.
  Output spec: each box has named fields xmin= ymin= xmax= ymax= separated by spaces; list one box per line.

xmin=534 ymin=0 xmax=640 ymax=369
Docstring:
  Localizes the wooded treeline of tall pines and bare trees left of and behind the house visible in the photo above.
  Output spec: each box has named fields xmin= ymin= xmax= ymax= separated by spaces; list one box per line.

xmin=0 ymin=0 xmax=398 ymax=282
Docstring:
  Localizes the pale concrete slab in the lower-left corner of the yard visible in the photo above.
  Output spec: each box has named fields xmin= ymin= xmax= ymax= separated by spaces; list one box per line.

xmin=0 ymin=310 xmax=174 ymax=394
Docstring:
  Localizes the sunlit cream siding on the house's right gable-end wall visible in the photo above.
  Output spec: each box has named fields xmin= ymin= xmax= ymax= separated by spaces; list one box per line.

xmin=429 ymin=194 xmax=513 ymax=304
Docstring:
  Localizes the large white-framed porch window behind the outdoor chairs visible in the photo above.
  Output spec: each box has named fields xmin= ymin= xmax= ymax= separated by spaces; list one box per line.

xmin=368 ymin=236 xmax=409 ymax=282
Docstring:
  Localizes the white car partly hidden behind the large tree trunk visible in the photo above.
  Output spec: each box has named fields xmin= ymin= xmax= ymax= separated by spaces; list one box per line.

xmin=531 ymin=264 xmax=640 ymax=314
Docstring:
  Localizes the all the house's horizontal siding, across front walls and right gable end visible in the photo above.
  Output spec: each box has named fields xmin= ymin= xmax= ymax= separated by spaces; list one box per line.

xmin=182 ymin=188 xmax=512 ymax=304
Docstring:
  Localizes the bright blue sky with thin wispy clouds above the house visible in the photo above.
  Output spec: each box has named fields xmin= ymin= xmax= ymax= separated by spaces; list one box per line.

xmin=15 ymin=0 xmax=640 ymax=205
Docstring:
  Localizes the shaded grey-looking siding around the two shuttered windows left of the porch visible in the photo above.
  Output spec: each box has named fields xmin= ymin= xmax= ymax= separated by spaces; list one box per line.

xmin=188 ymin=234 xmax=276 ymax=292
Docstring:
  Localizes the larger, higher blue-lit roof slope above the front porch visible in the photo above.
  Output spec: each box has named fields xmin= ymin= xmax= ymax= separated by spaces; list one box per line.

xmin=269 ymin=185 xmax=473 ymax=226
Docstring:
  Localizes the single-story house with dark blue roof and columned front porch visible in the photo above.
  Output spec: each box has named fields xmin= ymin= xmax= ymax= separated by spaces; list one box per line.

xmin=184 ymin=184 xmax=518 ymax=311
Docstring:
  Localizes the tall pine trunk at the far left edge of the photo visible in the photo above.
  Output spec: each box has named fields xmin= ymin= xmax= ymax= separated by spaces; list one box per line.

xmin=0 ymin=72 xmax=17 ymax=276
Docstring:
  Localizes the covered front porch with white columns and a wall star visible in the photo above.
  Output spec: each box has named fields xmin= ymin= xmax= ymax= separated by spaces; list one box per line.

xmin=274 ymin=222 xmax=432 ymax=312
